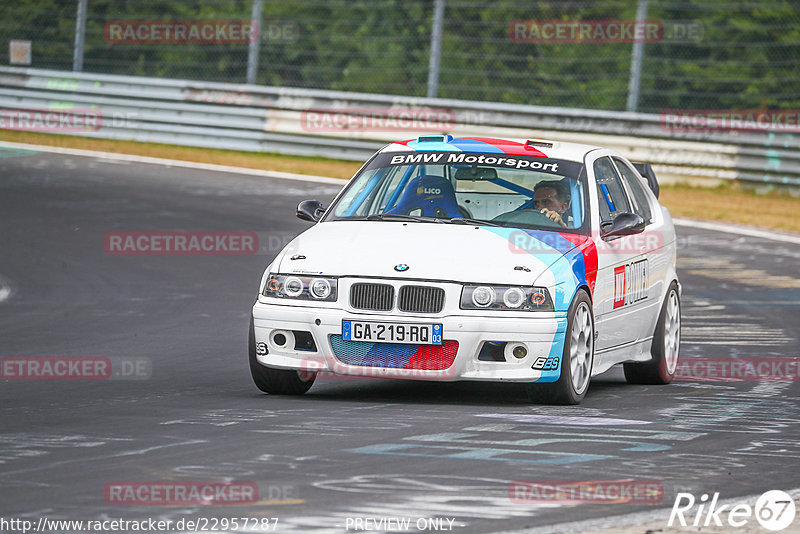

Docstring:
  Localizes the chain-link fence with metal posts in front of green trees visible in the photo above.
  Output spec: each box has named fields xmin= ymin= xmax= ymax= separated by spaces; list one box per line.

xmin=0 ymin=0 xmax=800 ymax=112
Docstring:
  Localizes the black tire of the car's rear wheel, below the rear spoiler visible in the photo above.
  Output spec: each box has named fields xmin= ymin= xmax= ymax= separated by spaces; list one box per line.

xmin=623 ymin=282 xmax=681 ymax=384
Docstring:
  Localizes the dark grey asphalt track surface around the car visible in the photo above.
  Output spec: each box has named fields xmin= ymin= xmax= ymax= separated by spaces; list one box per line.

xmin=0 ymin=150 xmax=800 ymax=532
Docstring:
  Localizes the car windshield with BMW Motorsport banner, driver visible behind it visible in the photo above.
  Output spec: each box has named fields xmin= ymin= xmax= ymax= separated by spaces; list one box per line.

xmin=325 ymin=152 xmax=588 ymax=232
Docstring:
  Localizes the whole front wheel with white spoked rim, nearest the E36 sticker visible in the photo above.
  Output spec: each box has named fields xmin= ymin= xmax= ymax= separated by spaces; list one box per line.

xmin=527 ymin=290 xmax=594 ymax=404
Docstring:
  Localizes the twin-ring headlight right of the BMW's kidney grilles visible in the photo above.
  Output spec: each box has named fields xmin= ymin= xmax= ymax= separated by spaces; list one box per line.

xmin=461 ymin=286 xmax=553 ymax=311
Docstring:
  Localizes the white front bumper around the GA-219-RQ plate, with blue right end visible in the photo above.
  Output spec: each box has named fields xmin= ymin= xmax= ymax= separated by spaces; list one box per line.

xmin=253 ymin=299 xmax=567 ymax=382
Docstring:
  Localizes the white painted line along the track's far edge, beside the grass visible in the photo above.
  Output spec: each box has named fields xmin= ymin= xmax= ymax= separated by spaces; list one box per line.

xmin=0 ymin=141 xmax=800 ymax=245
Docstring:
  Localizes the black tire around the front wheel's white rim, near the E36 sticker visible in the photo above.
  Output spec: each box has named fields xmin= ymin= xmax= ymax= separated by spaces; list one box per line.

xmin=526 ymin=290 xmax=594 ymax=404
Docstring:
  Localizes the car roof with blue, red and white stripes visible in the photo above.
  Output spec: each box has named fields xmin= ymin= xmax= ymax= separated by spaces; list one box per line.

xmin=380 ymin=134 xmax=600 ymax=162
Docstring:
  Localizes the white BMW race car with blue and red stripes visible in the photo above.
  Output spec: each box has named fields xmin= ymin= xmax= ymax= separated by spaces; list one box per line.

xmin=249 ymin=135 xmax=680 ymax=404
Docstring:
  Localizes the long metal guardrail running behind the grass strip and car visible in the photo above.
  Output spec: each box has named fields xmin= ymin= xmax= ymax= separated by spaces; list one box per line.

xmin=0 ymin=67 xmax=800 ymax=186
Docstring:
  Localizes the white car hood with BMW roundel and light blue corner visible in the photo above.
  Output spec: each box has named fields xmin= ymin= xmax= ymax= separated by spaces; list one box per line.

xmin=276 ymin=221 xmax=576 ymax=285
